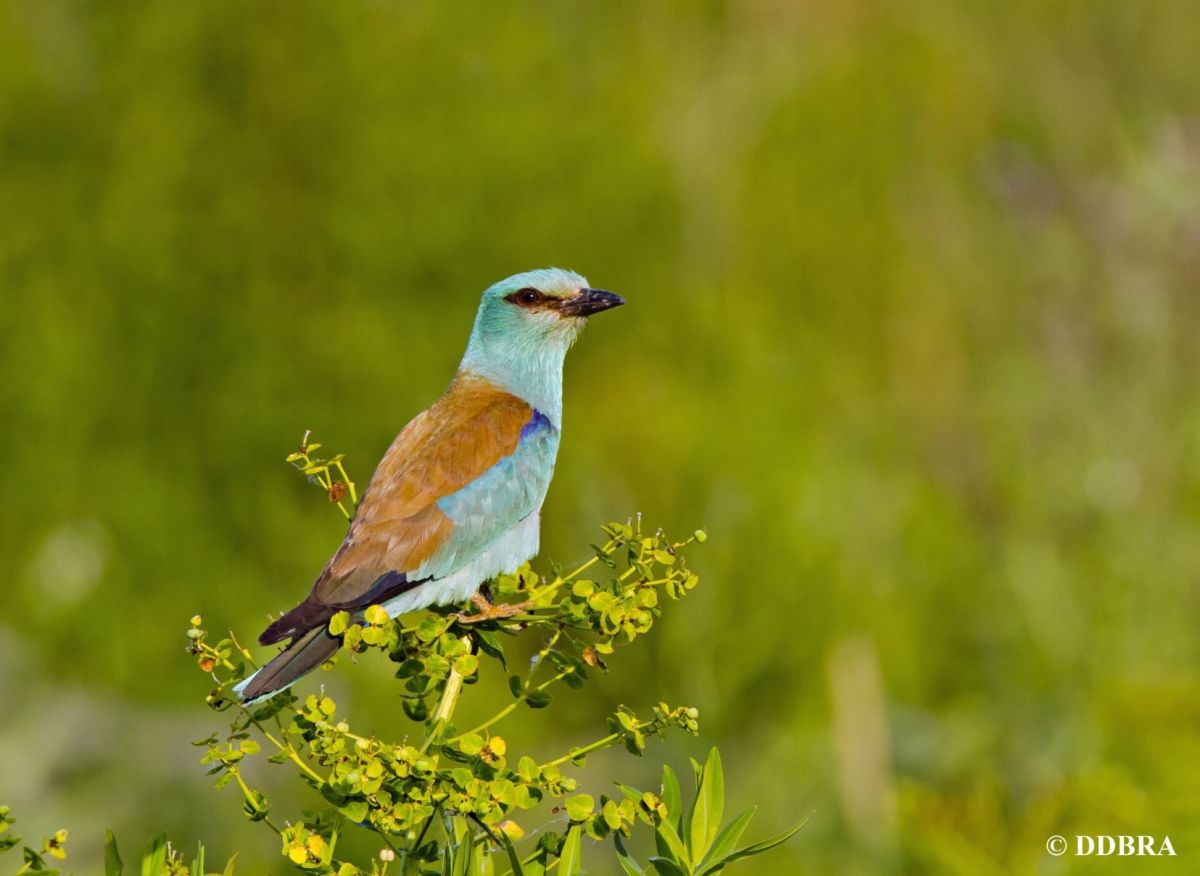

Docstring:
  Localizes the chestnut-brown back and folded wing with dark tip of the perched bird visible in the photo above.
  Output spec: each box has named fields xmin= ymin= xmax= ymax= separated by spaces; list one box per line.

xmin=259 ymin=376 xmax=533 ymax=644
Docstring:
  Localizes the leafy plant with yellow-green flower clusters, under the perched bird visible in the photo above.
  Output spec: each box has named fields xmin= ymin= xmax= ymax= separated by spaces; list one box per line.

xmin=180 ymin=434 xmax=794 ymax=876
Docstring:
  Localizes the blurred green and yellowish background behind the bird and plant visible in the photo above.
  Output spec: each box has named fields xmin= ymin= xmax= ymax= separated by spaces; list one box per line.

xmin=0 ymin=0 xmax=1200 ymax=874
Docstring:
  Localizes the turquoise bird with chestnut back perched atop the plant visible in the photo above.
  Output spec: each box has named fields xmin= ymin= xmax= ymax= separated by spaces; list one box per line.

xmin=234 ymin=268 xmax=625 ymax=706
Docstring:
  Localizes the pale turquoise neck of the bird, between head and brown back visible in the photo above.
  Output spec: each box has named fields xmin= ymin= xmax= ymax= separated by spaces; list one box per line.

xmin=458 ymin=335 xmax=569 ymax=430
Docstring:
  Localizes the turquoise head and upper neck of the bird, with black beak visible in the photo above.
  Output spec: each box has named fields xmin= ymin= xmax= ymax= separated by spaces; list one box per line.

xmin=462 ymin=268 xmax=625 ymax=412
